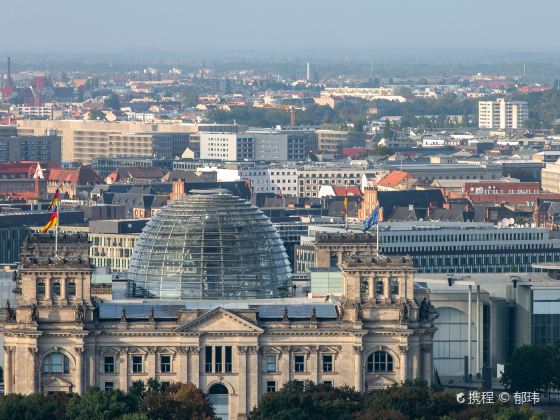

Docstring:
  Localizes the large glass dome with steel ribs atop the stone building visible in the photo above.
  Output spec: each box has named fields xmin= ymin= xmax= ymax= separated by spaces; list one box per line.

xmin=127 ymin=190 xmax=291 ymax=299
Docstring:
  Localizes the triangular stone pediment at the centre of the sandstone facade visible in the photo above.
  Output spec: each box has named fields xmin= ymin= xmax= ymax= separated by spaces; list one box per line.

xmin=175 ymin=307 xmax=264 ymax=334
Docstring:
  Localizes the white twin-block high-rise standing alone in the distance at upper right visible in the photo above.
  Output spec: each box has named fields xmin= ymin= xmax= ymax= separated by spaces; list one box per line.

xmin=478 ymin=98 xmax=529 ymax=130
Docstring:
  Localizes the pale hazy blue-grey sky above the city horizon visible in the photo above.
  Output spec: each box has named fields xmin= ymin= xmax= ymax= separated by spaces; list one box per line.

xmin=4 ymin=0 xmax=560 ymax=53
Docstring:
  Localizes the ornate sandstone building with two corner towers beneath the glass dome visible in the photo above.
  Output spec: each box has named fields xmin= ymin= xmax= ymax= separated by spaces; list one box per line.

xmin=2 ymin=234 xmax=436 ymax=418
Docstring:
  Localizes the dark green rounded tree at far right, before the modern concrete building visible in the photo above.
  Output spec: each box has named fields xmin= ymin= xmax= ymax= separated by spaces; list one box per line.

xmin=501 ymin=345 xmax=555 ymax=392
